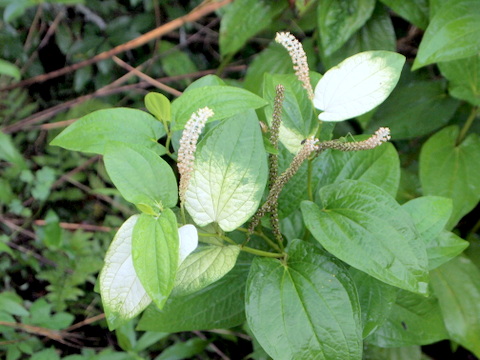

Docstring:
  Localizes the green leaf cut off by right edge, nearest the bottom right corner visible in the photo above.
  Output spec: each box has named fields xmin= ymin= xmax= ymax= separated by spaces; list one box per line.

xmin=431 ymin=256 xmax=480 ymax=357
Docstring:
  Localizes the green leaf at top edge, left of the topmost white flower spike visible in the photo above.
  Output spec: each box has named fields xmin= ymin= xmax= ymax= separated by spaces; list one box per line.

xmin=220 ymin=0 xmax=287 ymax=57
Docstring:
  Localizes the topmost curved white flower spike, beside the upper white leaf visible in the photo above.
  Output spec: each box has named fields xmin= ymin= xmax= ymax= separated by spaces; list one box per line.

xmin=275 ymin=32 xmax=314 ymax=100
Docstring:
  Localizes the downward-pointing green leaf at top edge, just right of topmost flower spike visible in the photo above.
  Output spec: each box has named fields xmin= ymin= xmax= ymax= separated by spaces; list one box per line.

xmin=318 ymin=0 xmax=375 ymax=56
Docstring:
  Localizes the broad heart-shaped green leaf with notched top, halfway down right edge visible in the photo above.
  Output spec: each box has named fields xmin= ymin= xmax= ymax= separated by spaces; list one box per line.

xmin=420 ymin=126 xmax=480 ymax=229
